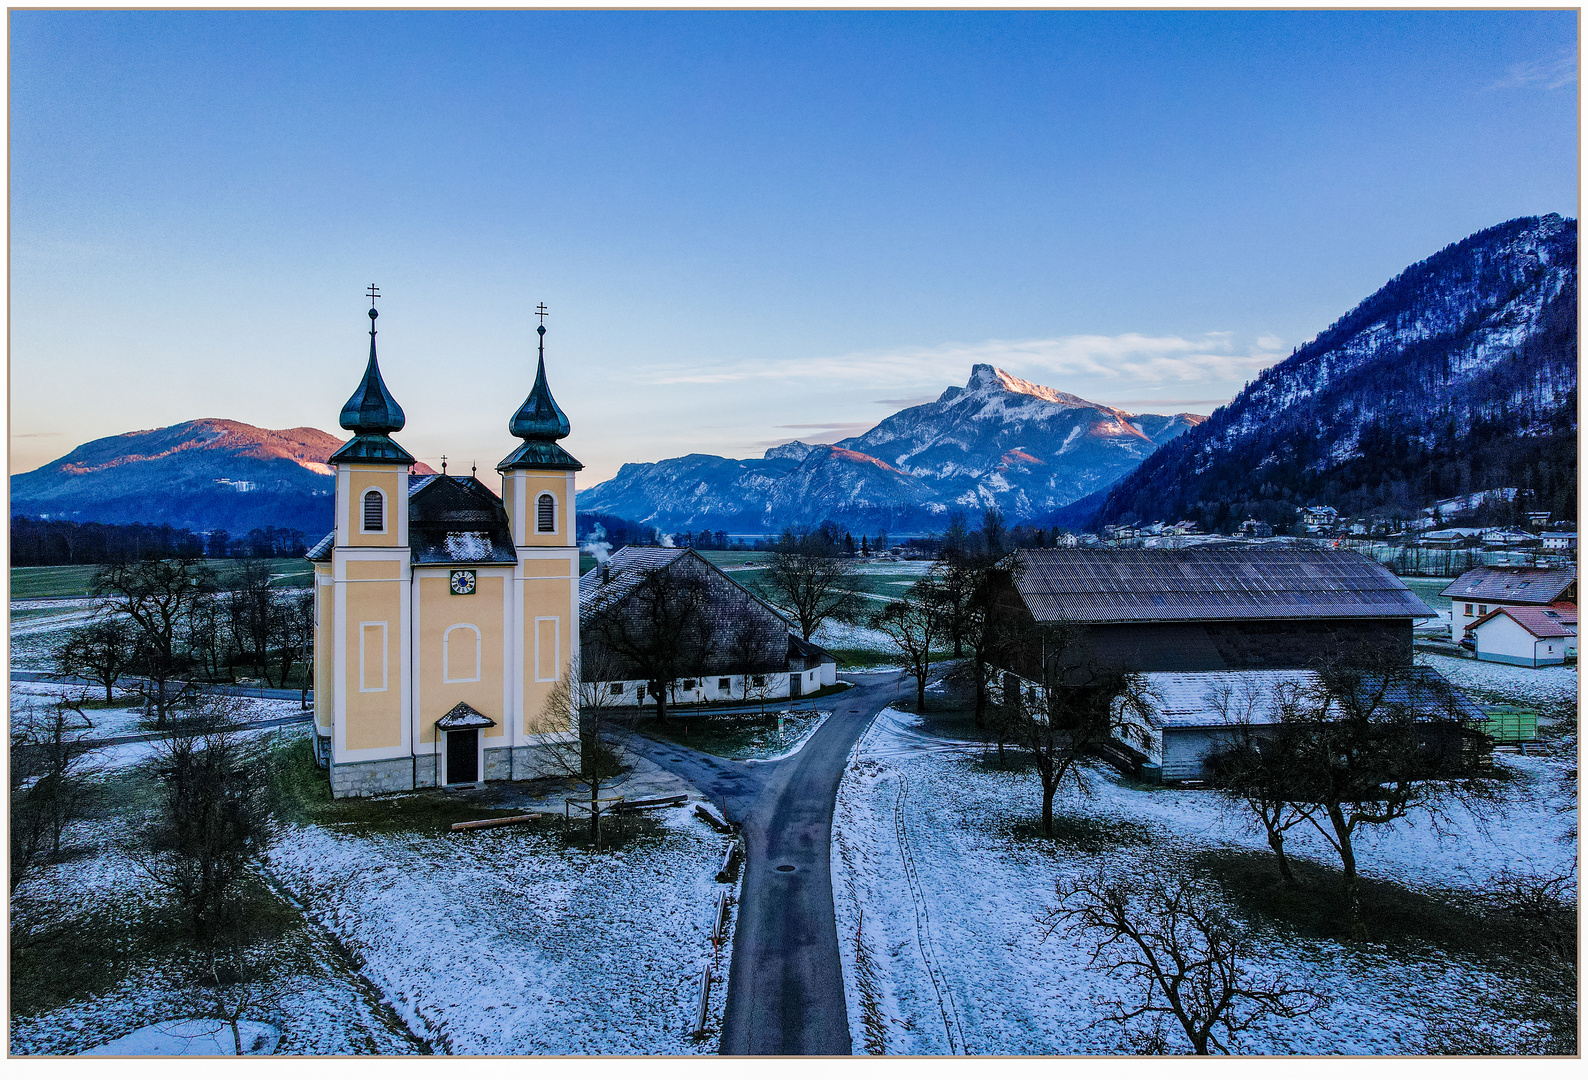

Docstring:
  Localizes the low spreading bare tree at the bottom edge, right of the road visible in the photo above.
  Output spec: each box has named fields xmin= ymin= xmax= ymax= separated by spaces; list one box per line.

xmin=1042 ymin=874 xmax=1324 ymax=1055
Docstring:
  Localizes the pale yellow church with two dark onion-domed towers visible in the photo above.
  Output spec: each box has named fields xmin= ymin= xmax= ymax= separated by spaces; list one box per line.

xmin=306 ymin=286 xmax=583 ymax=797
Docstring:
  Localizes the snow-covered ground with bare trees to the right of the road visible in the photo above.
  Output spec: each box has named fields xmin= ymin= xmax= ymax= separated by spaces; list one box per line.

xmin=832 ymin=710 xmax=1575 ymax=1055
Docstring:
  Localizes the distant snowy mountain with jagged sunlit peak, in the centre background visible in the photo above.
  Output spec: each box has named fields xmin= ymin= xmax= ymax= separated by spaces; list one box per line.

xmin=580 ymin=364 xmax=1204 ymax=532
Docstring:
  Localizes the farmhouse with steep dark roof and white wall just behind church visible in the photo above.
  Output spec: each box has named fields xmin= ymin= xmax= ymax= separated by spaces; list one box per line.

xmin=580 ymin=548 xmax=838 ymax=705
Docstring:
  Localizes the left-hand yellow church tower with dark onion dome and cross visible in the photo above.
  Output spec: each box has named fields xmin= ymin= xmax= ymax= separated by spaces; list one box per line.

xmin=310 ymin=295 xmax=414 ymax=794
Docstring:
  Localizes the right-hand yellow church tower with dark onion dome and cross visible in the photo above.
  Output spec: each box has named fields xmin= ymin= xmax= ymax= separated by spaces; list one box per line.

xmin=497 ymin=305 xmax=584 ymax=759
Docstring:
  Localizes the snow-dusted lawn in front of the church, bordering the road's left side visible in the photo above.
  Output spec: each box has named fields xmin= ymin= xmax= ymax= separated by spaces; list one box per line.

xmin=270 ymin=799 xmax=726 ymax=1055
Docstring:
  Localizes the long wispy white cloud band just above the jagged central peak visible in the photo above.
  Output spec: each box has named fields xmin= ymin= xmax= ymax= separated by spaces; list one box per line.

xmin=642 ymin=332 xmax=1283 ymax=397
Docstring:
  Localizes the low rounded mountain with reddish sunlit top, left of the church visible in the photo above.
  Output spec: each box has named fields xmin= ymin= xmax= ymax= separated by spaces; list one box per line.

xmin=11 ymin=419 xmax=430 ymax=535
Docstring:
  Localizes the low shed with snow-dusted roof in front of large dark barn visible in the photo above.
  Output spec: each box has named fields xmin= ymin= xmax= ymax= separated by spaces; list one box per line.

xmin=1123 ymin=667 xmax=1490 ymax=783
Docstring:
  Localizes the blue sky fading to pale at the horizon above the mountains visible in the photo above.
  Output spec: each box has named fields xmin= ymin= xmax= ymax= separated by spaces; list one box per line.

xmin=10 ymin=11 xmax=1578 ymax=486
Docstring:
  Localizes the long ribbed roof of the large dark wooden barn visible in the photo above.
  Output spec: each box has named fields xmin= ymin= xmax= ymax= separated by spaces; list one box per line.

xmin=1015 ymin=545 xmax=1434 ymax=623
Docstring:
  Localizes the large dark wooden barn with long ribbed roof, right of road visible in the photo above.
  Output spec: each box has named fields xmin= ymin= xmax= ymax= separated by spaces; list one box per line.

xmin=1004 ymin=545 xmax=1432 ymax=677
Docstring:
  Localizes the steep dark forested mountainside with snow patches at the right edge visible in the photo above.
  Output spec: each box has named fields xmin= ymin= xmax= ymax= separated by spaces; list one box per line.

xmin=1079 ymin=214 xmax=1577 ymax=529
